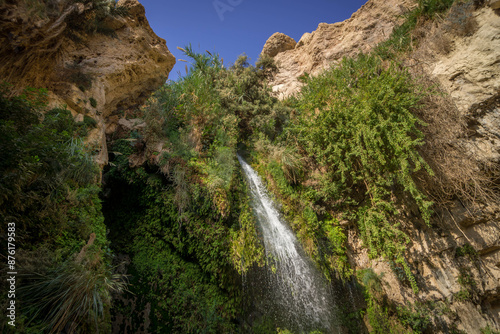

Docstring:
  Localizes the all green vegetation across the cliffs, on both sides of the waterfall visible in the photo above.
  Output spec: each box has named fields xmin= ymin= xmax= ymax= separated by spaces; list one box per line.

xmin=0 ymin=0 xmax=493 ymax=334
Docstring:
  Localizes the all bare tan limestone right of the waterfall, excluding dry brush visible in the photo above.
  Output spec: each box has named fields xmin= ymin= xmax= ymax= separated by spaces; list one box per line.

xmin=266 ymin=0 xmax=500 ymax=334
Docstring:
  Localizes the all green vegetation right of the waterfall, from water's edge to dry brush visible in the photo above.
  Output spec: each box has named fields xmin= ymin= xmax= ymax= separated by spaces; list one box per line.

xmin=255 ymin=55 xmax=432 ymax=293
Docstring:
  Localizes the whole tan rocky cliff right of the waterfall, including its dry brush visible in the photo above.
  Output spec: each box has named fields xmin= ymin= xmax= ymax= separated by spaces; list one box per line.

xmin=263 ymin=0 xmax=500 ymax=334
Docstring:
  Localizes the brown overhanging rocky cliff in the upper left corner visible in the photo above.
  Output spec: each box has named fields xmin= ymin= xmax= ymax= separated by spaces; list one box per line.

xmin=0 ymin=0 xmax=175 ymax=165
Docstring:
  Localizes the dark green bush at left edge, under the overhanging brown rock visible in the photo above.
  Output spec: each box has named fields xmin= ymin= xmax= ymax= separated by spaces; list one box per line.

xmin=0 ymin=85 xmax=97 ymax=242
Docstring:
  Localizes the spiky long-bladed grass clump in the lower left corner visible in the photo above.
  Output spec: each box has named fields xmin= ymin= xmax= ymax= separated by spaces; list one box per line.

xmin=19 ymin=261 xmax=125 ymax=333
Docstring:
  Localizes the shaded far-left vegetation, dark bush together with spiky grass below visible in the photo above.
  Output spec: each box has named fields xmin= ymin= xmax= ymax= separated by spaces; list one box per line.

xmin=0 ymin=84 xmax=119 ymax=333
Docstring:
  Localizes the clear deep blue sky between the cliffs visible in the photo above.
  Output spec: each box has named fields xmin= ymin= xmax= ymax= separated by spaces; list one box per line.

xmin=139 ymin=0 xmax=366 ymax=80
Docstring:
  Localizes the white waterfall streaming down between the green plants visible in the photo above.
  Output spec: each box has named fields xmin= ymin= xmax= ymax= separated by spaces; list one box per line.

xmin=238 ymin=155 xmax=339 ymax=333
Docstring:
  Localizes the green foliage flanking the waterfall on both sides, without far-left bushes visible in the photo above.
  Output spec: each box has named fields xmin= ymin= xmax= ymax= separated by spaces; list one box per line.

xmin=105 ymin=36 xmax=438 ymax=332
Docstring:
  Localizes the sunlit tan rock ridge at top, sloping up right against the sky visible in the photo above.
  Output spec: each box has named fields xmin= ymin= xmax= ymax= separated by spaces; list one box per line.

xmin=263 ymin=0 xmax=415 ymax=98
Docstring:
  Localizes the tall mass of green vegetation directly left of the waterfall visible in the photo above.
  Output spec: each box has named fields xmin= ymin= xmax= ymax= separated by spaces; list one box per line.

xmin=104 ymin=47 xmax=288 ymax=333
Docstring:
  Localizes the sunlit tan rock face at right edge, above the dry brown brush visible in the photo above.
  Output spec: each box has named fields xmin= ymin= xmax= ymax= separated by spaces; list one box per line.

xmin=428 ymin=6 xmax=500 ymax=166
